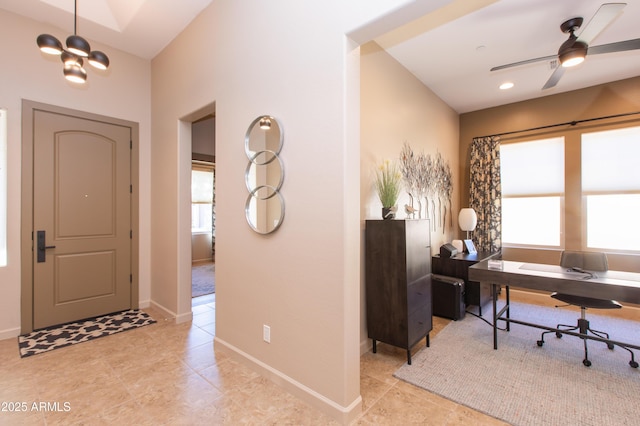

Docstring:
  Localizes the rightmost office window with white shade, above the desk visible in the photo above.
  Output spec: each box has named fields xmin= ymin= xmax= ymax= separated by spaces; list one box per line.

xmin=581 ymin=127 xmax=640 ymax=251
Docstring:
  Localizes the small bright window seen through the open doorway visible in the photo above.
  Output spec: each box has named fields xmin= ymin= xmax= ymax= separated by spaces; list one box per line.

xmin=191 ymin=164 xmax=214 ymax=234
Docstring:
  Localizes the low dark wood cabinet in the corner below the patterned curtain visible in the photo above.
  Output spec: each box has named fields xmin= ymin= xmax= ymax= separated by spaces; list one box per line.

xmin=432 ymin=251 xmax=500 ymax=315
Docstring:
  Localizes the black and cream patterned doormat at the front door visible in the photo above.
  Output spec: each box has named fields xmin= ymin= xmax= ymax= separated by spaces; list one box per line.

xmin=18 ymin=309 xmax=156 ymax=358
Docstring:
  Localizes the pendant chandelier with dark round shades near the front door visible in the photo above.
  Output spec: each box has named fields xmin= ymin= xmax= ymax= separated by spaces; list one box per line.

xmin=37 ymin=0 xmax=109 ymax=83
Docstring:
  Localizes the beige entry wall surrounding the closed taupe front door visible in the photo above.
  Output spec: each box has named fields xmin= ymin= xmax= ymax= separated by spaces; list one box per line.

xmin=0 ymin=10 xmax=151 ymax=339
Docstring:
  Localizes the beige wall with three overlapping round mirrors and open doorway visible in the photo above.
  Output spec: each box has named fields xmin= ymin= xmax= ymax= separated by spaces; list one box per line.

xmin=151 ymin=0 xmax=430 ymax=420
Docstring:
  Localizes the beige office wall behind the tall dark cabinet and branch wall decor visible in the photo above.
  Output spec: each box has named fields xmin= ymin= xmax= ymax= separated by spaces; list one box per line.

xmin=360 ymin=42 xmax=460 ymax=351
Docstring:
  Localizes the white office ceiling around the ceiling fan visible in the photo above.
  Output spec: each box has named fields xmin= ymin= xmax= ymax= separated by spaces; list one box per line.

xmin=376 ymin=0 xmax=640 ymax=113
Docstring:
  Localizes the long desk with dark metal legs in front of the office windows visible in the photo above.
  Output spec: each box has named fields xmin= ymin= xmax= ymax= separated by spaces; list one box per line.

xmin=469 ymin=260 xmax=640 ymax=350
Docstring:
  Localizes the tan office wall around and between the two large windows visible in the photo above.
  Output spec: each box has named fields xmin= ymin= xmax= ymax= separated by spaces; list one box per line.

xmin=460 ymin=77 xmax=640 ymax=272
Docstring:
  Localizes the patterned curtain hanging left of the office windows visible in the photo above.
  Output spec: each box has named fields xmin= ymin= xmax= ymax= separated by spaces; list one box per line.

xmin=469 ymin=136 xmax=502 ymax=251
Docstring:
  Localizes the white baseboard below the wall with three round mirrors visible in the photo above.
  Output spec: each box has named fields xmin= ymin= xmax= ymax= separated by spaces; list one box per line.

xmin=214 ymin=336 xmax=362 ymax=425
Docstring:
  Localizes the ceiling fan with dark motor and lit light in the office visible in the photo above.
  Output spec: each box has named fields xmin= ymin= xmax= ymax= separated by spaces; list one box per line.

xmin=491 ymin=3 xmax=640 ymax=90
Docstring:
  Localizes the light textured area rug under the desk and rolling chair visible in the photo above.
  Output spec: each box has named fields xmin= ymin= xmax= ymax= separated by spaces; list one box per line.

xmin=394 ymin=303 xmax=640 ymax=425
